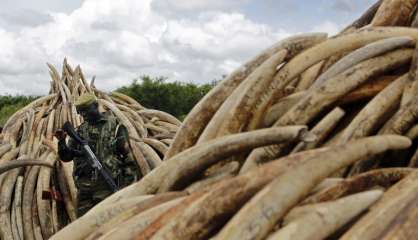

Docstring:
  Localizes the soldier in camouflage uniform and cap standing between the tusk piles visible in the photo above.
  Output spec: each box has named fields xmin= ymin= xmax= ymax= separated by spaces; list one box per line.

xmin=55 ymin=93 xmax=140 ymax=217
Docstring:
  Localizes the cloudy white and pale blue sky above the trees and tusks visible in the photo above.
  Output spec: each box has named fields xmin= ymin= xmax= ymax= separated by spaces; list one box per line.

xmin=0 ymin=0 xmax=375 ymax=95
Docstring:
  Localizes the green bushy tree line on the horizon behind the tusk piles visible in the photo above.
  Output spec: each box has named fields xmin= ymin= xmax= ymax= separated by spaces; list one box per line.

xmin=0 ymin=75 xmax=218 ymax=126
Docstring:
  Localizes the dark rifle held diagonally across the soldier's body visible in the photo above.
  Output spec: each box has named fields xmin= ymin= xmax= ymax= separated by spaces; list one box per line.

xmin=62 ymin=122 xmax=118 ymax=192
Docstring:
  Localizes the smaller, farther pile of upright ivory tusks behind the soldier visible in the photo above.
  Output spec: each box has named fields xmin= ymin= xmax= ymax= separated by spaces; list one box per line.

xmin=0 ymin=61 xmax=181 ymax=240
